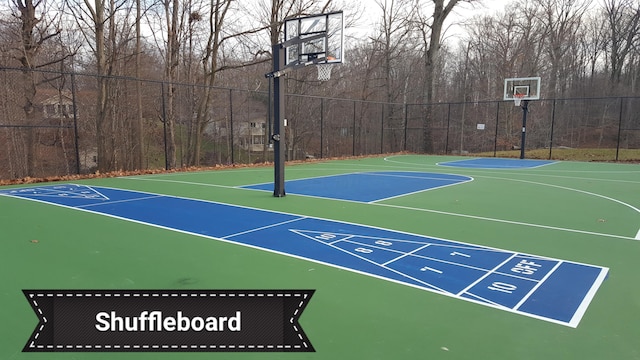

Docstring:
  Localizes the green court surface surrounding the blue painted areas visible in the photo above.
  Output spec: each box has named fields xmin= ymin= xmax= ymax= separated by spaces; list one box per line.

xmin=0 ymin=155 xmax=640 ymax=360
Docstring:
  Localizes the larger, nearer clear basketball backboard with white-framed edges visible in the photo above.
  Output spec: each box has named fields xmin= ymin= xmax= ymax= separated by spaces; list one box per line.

xmin=284 ymin=11 xmax=344 ymax=66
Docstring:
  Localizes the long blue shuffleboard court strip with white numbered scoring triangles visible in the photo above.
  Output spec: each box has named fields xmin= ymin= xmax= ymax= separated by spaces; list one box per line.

xmin=0 ymin=184 xmax=608 ymax=327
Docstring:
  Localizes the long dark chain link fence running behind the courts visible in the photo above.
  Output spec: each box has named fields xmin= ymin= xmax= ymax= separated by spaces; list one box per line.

xmin=0 ymin=68 xmax=640 ymax=179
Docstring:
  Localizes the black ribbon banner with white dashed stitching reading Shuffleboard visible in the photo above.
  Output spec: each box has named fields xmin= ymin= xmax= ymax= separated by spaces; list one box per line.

xmin=22 ymin=290 xmax=315 ymax=352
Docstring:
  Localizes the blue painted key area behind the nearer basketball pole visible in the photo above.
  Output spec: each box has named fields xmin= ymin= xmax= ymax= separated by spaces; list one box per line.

xmin=243 ymin=171 xmax=473 ymax=203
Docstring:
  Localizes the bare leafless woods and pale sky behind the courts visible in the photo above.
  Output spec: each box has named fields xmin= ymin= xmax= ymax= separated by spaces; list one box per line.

xmin=0 ymin=0 xmax=640 ymax=179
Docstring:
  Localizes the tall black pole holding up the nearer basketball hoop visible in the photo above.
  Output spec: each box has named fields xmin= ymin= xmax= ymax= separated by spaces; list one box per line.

xmin=271 ymin=44 xmax=286 ymax=197
